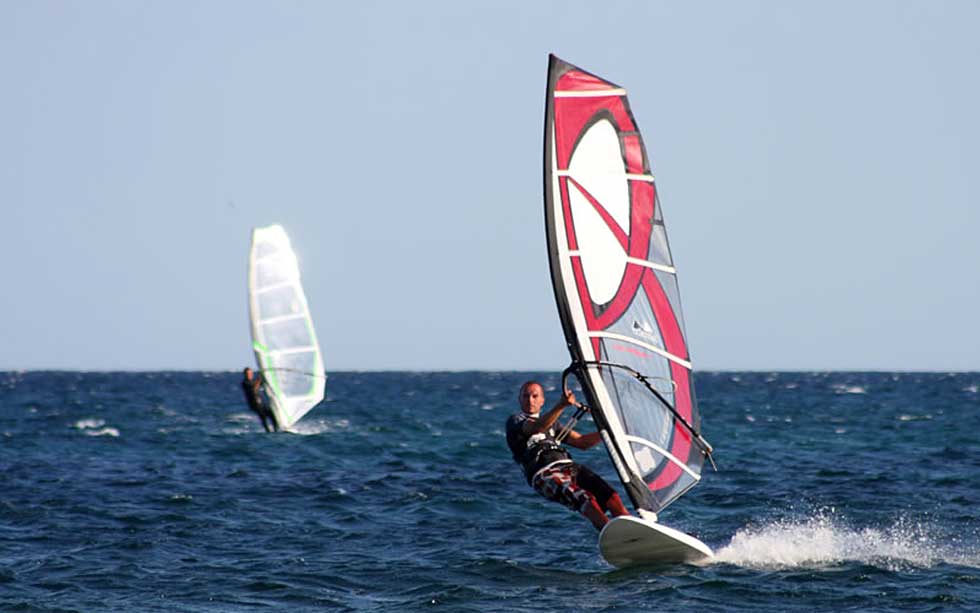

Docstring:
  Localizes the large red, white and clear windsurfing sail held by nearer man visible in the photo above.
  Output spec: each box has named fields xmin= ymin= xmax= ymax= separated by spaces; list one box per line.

xmin=544 ymin=56 xmax=704 ymax=512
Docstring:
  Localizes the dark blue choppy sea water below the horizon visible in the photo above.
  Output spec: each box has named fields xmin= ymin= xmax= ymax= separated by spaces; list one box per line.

xmin=0 ymin=372 xmax=980 ymax=611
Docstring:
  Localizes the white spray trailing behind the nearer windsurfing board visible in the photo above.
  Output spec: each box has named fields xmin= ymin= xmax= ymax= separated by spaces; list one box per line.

xmin=715 ymin=514 xmax=980 ymax=570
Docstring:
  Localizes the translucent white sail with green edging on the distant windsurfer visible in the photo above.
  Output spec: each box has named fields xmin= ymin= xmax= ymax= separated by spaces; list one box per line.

xmin=248 ymin=225 xmax=326 ymax=429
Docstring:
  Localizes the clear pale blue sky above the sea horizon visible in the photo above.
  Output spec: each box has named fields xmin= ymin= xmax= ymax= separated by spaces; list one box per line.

xmin=0 ymin=0 xmax=980 ymax=371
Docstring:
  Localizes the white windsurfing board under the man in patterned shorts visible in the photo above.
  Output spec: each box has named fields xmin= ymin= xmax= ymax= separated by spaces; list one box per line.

xmin=599 ymin=516 xmax=714 ymax=568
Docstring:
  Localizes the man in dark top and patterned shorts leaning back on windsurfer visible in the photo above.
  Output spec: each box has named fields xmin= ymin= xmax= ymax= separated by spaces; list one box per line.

xmin=507 ymin=381 xmax=629 ymax=530
